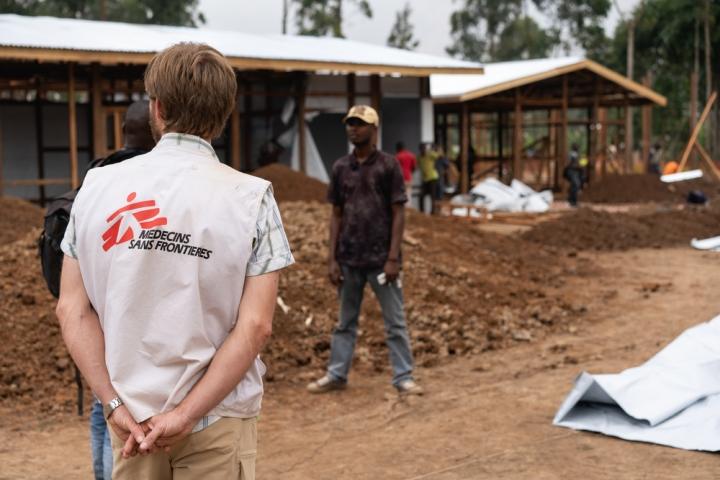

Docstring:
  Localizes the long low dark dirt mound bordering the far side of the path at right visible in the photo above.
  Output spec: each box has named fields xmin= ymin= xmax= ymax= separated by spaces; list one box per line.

xmin=522 ymin=205 xmax=720 ymax=250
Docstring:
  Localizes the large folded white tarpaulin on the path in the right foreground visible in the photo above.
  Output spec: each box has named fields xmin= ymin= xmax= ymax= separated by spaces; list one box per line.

xmin=553 ymin=316 xmax=720 ymax=452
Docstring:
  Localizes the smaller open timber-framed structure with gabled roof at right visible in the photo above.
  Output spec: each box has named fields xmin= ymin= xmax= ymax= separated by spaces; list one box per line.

xmin=433 ymin=59 xmax=667 ymax=192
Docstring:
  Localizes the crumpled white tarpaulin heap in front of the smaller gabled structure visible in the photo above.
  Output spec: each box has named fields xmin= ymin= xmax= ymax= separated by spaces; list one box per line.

xmin=451 ymin=178 xmax=553 ymax=216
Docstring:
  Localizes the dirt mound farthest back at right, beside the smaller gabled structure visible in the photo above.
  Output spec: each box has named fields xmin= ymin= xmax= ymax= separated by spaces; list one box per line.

xmin=581 ymin=174 xmax=720 ymax=203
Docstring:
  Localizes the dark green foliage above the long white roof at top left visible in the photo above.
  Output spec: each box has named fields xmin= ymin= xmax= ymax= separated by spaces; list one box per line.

xmin=0 ymin=0 xmax=205 ymax=27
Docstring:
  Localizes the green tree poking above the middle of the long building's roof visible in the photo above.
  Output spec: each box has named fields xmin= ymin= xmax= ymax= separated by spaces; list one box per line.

xmin=293 ymin=0 xmax=372 ymax=38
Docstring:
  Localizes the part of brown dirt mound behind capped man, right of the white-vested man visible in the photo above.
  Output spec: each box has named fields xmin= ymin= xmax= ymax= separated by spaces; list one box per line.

xmin=265 ymin=202 xmax=595 ymax=381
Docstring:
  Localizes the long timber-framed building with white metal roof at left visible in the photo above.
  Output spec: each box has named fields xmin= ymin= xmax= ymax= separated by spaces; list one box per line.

xmin=0 ymin=15 xmax=483 ymax=204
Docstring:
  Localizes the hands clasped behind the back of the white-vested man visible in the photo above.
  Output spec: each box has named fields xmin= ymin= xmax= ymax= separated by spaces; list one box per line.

xmin=108 ymin=405 xmax=198 ymax=458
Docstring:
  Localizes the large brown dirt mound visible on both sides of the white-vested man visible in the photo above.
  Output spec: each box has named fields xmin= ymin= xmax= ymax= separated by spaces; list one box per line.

xmin=0 ymin=197 xmax=597 ymax=413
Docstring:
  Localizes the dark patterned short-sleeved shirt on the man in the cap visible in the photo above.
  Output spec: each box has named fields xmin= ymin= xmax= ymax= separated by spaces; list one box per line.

xmin=328 ymin=150 xmax=407 ymax=268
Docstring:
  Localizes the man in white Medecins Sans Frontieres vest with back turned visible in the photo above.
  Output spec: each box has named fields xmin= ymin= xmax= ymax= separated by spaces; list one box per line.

xmin=57 ymin=43 xmax=293 ymax=480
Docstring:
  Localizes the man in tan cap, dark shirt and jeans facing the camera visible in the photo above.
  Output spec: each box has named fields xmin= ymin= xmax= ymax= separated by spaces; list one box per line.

xmin=307 ymin=105 xmax=422 ymax=394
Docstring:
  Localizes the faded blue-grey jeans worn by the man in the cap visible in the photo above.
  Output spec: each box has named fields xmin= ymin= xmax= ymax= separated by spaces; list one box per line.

xmin=328 ymin=265 xmax=413 ymax=386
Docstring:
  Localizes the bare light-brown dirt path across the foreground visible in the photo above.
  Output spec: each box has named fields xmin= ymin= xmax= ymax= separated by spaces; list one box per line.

xmin=0 ymin=249 xmax=720 ymax=480
